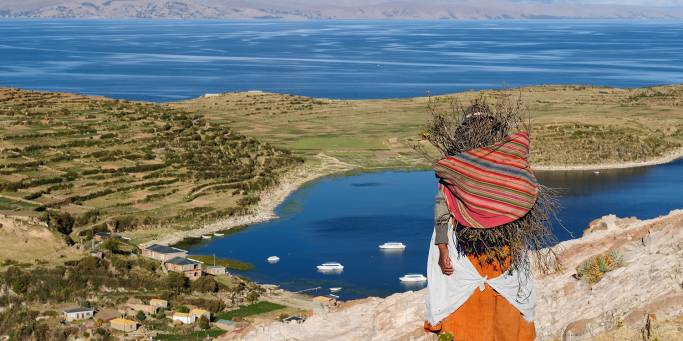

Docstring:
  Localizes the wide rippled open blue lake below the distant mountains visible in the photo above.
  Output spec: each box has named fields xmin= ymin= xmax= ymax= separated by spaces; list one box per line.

xmin=0 ymin=20 xmax=683 ymax=101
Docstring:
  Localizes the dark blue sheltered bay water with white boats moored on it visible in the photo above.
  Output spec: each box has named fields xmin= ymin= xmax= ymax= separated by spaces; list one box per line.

xmin=191 ymin=159 xmax=683 ymax=299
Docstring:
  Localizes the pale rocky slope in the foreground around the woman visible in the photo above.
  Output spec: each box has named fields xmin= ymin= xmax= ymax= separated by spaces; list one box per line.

xmin=236 ymin=210 xmax=683 ymax=341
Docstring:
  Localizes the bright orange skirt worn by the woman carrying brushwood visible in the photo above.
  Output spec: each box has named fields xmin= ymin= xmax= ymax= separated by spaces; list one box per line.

xmin=425 ymin=255 xmax=536 ymax=341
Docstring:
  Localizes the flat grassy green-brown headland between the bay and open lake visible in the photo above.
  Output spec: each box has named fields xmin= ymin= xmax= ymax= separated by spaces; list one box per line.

xmin=172 ymin=85 xmax=683 ymax=167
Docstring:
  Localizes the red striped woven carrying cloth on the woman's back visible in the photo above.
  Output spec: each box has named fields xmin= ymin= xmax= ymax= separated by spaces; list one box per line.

xmin=434 ymin=132 xmax=538 ymax=228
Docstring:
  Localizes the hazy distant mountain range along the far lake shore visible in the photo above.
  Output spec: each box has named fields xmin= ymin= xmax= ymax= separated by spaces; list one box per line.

xmin=0 ymin=0 xmax=683 ymax=19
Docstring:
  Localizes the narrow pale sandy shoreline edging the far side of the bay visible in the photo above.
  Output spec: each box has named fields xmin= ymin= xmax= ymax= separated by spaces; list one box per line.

xmin=139 ymin=147 xmax=683 ymax=247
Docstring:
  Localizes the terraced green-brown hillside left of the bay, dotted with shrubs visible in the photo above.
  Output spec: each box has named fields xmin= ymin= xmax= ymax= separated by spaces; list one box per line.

xmin=0 ymin=89 xmax=303 ymax=237
